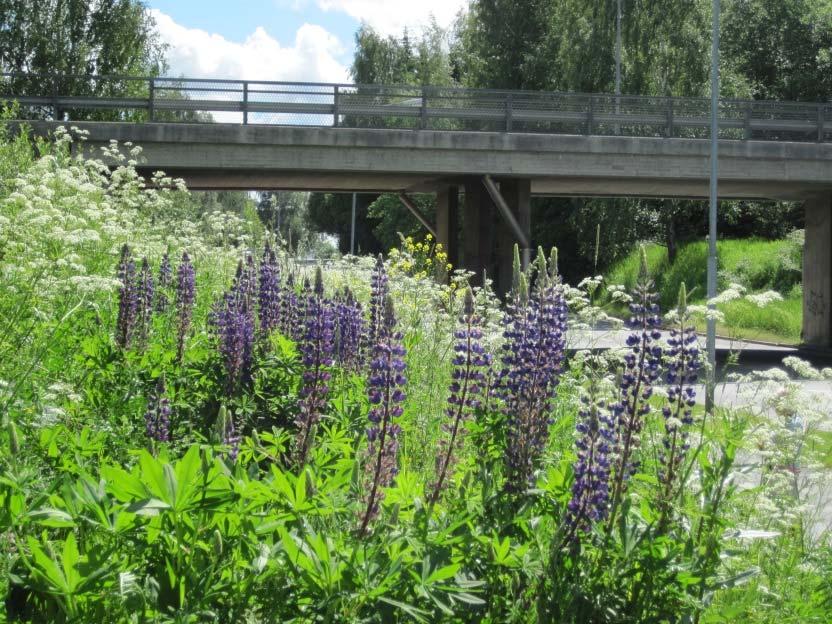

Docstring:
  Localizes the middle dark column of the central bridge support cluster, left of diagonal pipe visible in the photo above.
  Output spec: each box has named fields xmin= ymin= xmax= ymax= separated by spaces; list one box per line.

xmin=462 ymin=177 xmax=494 ymax=285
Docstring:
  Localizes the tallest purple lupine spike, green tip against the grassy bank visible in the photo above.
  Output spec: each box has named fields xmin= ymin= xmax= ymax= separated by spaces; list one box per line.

xmin=611 ymin=247 xmax=662 ymax=521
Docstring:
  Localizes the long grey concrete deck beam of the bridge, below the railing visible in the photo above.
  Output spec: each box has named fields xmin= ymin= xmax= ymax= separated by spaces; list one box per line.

xmin=22 ymin=122 xmax=832 ymax=199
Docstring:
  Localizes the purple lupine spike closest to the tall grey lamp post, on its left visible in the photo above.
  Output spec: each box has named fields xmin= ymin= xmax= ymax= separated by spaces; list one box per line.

xmin=659 ymin=283 xmax=701 ymax=516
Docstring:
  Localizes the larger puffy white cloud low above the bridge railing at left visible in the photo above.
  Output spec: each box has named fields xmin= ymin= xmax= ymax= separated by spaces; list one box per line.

xmin=151 ymin=9 xmax=349 ymax=82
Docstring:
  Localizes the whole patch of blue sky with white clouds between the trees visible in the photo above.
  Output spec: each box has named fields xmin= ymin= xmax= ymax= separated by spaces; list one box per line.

xmin=146 ymin=0 xmax=467 ymax=82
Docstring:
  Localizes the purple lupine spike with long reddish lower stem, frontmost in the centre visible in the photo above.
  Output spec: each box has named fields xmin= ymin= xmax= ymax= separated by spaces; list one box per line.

xmin=359 ymin=295 xmax=407 ymax=535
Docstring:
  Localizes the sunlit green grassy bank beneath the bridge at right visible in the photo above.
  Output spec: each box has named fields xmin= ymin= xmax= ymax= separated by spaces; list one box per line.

xmin=607 ymin=239 xmax=803 ymax=343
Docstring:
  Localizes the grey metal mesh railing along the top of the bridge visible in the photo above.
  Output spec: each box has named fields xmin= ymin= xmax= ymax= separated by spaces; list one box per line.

xmin=0 ymin=74 xmax=832 ymax=142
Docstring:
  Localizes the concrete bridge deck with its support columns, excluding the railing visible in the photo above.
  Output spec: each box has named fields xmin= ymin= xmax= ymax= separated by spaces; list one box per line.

xmin=24 ymin=122 xmax=832 ymax=349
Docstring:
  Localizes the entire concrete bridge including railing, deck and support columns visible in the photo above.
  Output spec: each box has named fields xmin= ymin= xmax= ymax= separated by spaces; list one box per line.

xmin=0 ymin=76 xmax=832 ymax=348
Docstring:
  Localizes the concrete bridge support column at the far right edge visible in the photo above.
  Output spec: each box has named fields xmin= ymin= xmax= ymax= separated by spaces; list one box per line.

xmin=803 ymin=194 xmax=832 ymax=349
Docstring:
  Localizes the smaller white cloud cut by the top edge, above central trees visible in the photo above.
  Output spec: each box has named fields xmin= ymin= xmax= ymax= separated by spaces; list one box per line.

xmin=317 ymin=0 xmax=468 ymax=35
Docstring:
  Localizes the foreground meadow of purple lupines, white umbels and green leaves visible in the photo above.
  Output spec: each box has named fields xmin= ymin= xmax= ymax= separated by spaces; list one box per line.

xmin=0 ymin=120 xmax=832 ymax=623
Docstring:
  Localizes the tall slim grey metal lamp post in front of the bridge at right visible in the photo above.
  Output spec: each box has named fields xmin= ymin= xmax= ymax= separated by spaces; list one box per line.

xmin=705 ymin=0 xmax=719 ymax=411
